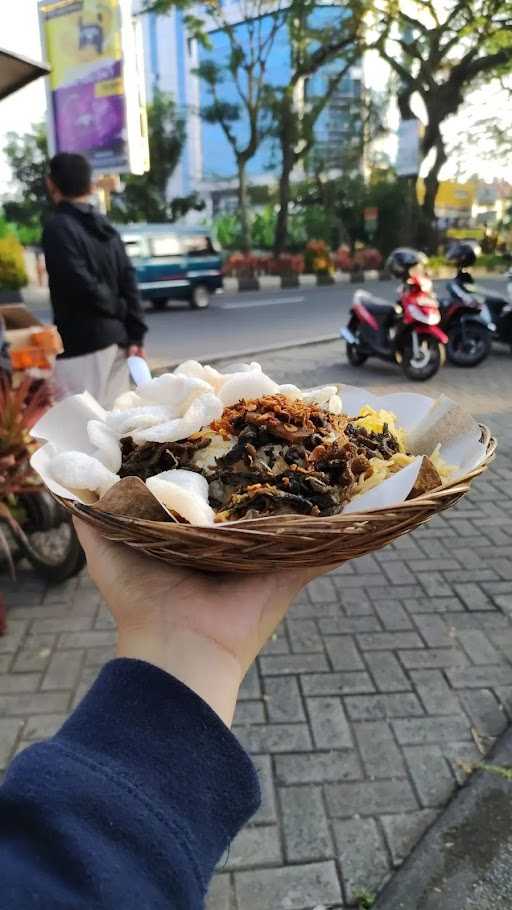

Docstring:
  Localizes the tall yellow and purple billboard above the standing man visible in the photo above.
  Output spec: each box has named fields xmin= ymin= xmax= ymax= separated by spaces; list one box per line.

xmin=39 ymin=0 xmax=149 ymax=174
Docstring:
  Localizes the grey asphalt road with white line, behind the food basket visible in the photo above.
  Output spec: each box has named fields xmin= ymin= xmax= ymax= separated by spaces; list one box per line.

xmin=25 ymin=278 xmax=505 ymax=366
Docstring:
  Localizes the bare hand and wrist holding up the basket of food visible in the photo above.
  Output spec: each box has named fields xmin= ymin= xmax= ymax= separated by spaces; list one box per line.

xmin=75 ymin=519 xmax=322 ymax=726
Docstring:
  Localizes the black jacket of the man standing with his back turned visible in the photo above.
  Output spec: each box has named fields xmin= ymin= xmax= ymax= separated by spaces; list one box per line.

xmin=43 ymin=202 xmax=146 ymax=357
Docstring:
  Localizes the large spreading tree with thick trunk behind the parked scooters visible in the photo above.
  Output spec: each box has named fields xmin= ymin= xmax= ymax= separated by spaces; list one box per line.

xmin=374 ymin=0 xmax=512 ymax=243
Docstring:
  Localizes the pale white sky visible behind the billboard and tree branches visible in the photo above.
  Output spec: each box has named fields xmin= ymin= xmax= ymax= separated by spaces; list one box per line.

xmin=0 ymin=0 xmax=512 ymax=196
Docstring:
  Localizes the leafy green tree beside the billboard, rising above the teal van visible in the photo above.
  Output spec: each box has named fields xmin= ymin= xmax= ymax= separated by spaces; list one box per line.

xmin=111 ymin=92 xmax=204 ymax=224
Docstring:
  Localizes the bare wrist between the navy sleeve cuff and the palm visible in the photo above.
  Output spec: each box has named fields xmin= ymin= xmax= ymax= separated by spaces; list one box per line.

xmin=117 ymin=627 xmax=242 ymax=727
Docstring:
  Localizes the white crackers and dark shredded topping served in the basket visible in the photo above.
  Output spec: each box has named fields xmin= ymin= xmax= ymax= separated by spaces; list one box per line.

xmin=42 ymin=361 xmax=451 ymax=526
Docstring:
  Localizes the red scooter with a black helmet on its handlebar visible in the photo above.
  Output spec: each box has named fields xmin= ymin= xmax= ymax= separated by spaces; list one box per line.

xmin=340 ymin=247 xmax=448 ymax=382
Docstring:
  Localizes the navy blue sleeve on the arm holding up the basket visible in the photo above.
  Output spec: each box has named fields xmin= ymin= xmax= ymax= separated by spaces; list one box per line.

xmin=0 ymin=659 xmax=260 ymax=910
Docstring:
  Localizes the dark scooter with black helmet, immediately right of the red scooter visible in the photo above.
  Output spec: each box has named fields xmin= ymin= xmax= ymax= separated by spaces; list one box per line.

xmin=440 ymin=240 xmax=512 ymax=367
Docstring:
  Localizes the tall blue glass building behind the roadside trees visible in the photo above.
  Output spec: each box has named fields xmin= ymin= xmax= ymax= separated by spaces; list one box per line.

xmin=142 ymin=0 xmax=362 ymax=209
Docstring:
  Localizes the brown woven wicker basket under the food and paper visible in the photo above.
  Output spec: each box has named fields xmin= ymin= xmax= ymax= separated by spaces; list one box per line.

xmin=56 ymin=426 xmax=496 ymax=572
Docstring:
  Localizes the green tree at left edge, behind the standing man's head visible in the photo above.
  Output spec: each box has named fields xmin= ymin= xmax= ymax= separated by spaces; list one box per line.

xmin=3 ymin=123 xmax=49 ymax=243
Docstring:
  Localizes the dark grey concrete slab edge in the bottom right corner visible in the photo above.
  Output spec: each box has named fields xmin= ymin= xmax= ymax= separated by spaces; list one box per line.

xmin=374 ymin=726 xmax=512 ymax=910
